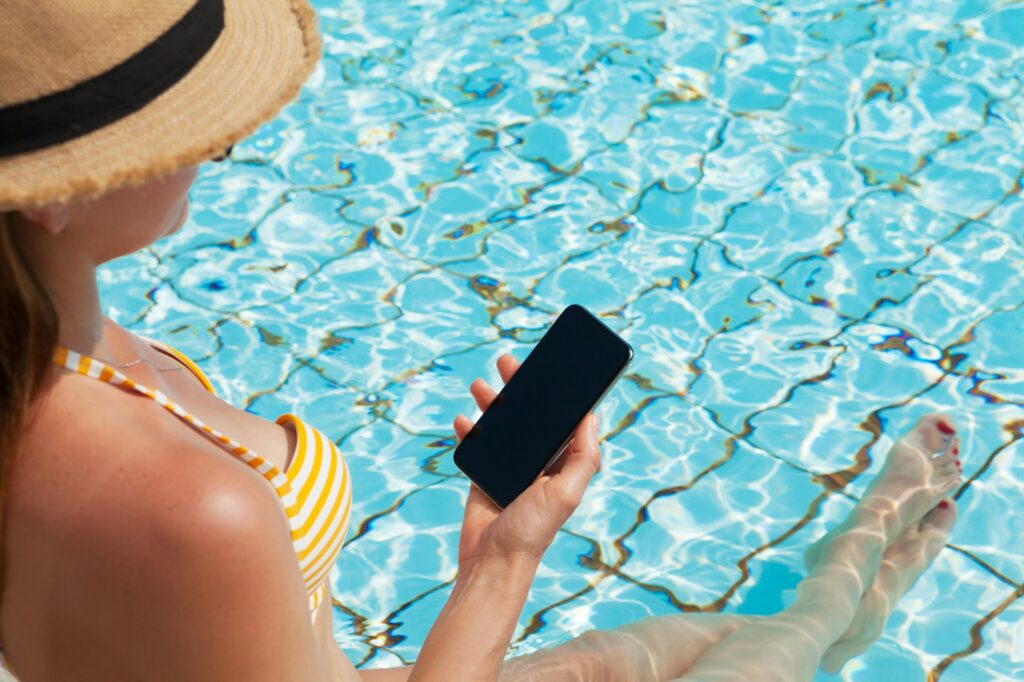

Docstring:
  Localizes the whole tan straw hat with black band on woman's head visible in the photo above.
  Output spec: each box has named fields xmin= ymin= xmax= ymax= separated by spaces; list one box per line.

xmin=0 ymin=0 xmax=322 ymax=211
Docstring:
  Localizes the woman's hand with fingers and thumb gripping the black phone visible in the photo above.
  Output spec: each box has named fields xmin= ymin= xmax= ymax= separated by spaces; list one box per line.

xmin=455 ymin=353 xmax=601 ymax=572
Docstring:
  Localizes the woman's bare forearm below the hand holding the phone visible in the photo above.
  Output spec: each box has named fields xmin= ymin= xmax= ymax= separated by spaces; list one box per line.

xmin=409 ymin=557 xmax=540 ymax=682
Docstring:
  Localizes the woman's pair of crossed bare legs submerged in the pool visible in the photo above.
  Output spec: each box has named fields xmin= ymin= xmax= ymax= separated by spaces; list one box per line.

xmin=501 ymin=415 xmax=956 ymax=682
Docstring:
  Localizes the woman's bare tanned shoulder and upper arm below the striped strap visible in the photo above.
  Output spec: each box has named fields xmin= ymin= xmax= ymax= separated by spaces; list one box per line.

xmin=4 ymin=374 xmax=323 ymax=679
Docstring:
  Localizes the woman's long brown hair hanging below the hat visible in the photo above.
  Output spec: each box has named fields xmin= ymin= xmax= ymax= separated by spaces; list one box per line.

xmin=0 ymin=211 xmax=60 ymax=614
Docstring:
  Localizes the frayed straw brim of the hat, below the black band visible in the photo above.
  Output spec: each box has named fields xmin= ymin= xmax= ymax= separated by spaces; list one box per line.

xmin=0 ymin=0 xmax=323 ymax=211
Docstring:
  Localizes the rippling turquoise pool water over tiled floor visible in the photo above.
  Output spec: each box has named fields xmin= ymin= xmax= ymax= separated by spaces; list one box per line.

xmin=101 ymin=0 xmax=1024 ymax=682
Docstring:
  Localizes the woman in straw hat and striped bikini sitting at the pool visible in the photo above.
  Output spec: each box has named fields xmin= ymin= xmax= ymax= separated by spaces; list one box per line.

xmin=0 ymin=0 xmax=958 ymax=682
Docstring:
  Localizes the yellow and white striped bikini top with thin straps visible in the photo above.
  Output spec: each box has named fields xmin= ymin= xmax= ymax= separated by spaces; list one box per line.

xmin=53 ymin=337 xmax=352 ymax=623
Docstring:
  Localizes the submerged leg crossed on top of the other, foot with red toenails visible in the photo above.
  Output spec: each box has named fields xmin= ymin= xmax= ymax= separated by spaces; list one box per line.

xmin=667 ymin=415 xmax=959 ymax=682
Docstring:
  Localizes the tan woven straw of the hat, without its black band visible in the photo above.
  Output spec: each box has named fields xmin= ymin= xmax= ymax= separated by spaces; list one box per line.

xmin=0 ymin=0 xmax=322 ymax=211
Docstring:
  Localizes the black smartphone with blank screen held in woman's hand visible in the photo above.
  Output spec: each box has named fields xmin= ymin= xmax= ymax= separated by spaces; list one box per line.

xmin=454 ymin=304 xmax=633 ymax=509
